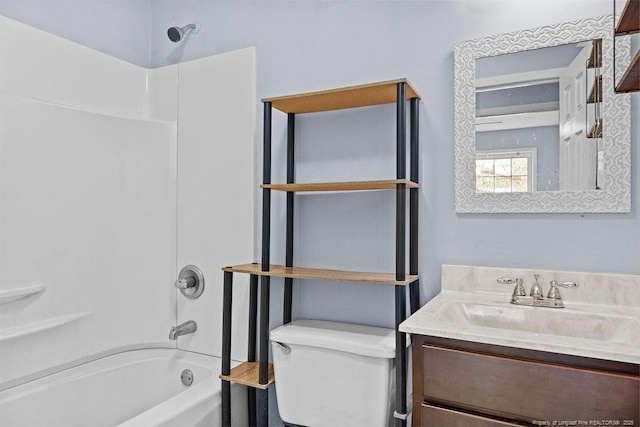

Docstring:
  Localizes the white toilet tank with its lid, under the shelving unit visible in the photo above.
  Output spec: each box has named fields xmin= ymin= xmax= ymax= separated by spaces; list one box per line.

xmin=270 ymin=320 xmax=395 ymax=427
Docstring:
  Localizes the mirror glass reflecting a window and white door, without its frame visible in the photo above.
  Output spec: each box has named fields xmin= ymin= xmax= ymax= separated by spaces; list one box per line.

xmin=475 ymin=39 xmax=602 ymax=193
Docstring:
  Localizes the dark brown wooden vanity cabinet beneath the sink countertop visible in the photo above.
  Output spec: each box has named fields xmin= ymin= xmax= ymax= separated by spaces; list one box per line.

xmin=413 ymin=335 xmax=640 ymax=427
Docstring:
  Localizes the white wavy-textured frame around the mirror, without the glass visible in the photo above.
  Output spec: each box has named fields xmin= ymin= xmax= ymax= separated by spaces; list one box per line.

xmin=454 ymin=15 xmax=631 ymax=213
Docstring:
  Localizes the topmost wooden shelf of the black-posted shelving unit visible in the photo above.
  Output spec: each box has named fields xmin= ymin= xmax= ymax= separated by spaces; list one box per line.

xmin=262 ymin=79 xmax=420 ymax=114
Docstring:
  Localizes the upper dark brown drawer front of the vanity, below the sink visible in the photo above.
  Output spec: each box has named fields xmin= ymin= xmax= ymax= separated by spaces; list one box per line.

xmin=422 ymin=345 xmax=640 ymax=425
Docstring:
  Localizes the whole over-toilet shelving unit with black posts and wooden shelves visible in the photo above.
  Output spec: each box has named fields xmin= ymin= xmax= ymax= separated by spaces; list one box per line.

xmin=220 ymin=79 xmax=420 ymax=426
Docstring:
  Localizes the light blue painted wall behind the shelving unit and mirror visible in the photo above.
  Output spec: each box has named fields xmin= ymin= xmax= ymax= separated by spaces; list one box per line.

xmin=2 ymin=0 xmax=640 ymax=424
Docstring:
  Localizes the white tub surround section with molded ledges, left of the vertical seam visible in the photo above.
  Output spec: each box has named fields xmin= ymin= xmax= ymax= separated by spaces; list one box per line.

xmin=0 ymin=17 xmax=176 ymax=389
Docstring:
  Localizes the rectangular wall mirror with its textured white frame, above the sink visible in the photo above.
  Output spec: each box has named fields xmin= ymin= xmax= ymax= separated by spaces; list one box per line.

xmin=455 ymin=16 xmax=631 ymax=213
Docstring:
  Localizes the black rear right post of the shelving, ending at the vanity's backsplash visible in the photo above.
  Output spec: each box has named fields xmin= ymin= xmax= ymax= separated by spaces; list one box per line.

xmin=409 ymin=98 xmax=420 ymax=314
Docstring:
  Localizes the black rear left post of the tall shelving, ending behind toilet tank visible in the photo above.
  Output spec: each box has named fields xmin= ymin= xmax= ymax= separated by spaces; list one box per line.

xmin=282 ymin=113 xmax=296 ymax=325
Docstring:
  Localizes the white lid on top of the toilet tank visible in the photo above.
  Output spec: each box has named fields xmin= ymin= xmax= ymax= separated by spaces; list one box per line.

xmin=270 ymin=319 xmax=400 ymax=359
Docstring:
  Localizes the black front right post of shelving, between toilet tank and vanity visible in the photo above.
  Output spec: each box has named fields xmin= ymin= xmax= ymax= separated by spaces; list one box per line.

xmin=394 ymin=82 xmax=407 ymax=426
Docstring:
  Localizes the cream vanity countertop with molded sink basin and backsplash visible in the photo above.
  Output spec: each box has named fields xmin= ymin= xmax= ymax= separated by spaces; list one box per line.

xmin=400 ymin=265 xmax=640 ymax=363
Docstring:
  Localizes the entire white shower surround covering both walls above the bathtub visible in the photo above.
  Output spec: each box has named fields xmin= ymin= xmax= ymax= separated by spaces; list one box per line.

xmin=0 ymin=17 xmax=256 ymax=418
